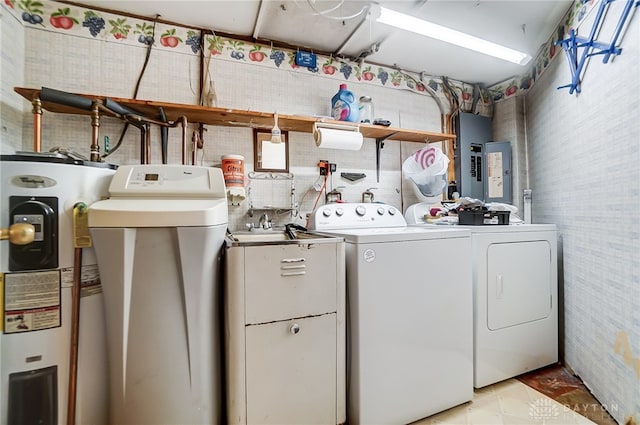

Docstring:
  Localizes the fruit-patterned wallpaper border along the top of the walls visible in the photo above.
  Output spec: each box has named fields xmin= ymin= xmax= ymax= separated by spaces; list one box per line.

xmin=2 ymin=0 xmax=597 ymax=111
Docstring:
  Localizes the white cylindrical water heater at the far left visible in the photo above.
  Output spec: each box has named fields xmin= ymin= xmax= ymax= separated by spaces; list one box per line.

xmin=0 ymin=152 xmax=115 ymax=424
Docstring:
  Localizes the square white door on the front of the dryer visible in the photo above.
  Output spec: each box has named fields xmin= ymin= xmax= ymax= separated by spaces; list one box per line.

xmin=487 ymin=241 xmax=553 ymax=330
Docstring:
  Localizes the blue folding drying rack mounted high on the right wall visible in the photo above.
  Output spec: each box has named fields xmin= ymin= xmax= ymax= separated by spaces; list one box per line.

xmin=555 ymin=0 xmax=640 ymax=94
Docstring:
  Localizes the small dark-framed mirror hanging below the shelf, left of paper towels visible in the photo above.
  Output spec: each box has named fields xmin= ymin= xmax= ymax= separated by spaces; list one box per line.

xmin=253 ymin=129 xmax=289 ymax=173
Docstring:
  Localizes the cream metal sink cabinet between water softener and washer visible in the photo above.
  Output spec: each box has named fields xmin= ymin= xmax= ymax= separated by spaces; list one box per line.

xmin=224 ymin=238 xmax=346 ymax=425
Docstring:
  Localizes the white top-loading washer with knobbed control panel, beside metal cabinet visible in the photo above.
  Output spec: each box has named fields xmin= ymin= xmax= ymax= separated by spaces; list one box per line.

xmin=309 ymin=203 xmax=473 ymax=425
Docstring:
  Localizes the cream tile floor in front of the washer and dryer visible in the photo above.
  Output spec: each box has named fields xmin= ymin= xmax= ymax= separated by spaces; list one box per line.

xmin=412 ymin=379 xmax=595 ymax=425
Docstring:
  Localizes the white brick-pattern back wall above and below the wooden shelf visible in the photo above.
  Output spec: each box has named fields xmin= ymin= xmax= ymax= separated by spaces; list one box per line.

xmin=3 ymin=21 xmax=441 ymax=230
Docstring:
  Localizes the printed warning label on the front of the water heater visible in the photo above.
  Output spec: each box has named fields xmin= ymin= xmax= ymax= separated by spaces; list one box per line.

xmin=3 ymin=270 xmax=61 ymax=334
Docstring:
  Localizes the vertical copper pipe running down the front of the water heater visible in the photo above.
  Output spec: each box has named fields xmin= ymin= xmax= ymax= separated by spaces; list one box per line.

xmin=67 ymin=248 xmax=82 ymax=425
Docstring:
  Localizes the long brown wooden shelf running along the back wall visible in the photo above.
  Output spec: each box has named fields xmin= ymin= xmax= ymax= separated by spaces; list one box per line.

xmin=14 ymin=87 xmax=456 ymax=143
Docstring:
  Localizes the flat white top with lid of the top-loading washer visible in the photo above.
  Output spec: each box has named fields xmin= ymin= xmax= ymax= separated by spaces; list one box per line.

xmin=322 ymin=226 xmax=471 ymax=243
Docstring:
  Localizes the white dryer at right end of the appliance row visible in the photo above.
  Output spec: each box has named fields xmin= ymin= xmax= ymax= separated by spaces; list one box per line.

xmin=405 ymin=204 xmax=558 ymax=388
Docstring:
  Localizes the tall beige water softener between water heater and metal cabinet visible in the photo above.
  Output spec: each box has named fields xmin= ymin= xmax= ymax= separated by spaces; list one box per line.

xmin=89 ymin=165 xmax=228 ymax=425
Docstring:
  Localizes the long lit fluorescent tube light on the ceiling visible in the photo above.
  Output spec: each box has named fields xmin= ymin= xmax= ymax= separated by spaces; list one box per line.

xmin=376 ymin=7 xmax=531 ymax=65
